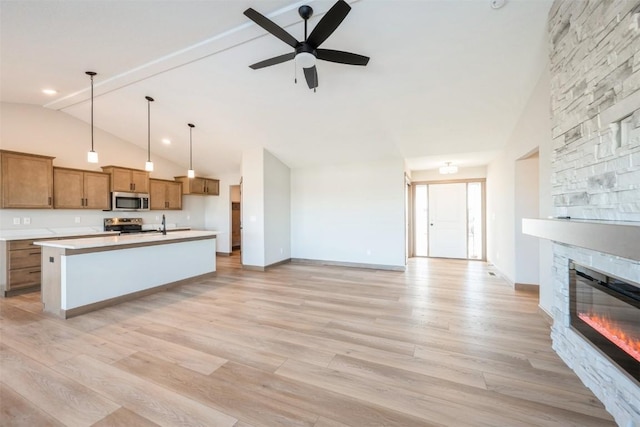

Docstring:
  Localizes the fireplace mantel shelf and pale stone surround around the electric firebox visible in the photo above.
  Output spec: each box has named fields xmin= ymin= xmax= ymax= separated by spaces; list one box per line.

xmin=522 ymin=219 xmax=640 ymax=427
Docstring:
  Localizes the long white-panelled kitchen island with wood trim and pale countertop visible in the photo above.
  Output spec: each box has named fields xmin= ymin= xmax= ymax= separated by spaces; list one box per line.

xmin=34 ymin=230 xmax=218 ymax=319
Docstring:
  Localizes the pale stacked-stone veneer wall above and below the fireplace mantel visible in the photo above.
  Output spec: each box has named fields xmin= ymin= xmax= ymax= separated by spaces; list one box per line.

xmin=549 ymin=0 xmax=640 ymax=426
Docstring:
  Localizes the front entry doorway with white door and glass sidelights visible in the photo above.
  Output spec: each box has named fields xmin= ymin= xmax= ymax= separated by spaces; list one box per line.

xmin=413 ymin=180 xmax=485 ymax=260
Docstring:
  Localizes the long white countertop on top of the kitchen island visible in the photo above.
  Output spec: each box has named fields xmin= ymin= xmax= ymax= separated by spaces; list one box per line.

xmin=34 ymin=230 xmax=219 ymax=250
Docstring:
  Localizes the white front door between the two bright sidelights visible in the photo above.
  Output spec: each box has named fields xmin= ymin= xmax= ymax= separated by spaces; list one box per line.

xmin=429 ymin=183 xmax=467 ymax=258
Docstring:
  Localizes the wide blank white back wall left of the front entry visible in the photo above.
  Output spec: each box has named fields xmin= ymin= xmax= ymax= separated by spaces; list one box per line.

xmin=291 ymin=159 xmax=405 ymax=268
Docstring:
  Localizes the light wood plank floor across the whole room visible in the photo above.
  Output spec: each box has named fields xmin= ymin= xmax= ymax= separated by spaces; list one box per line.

xmin=0 ymin=254 xmax=614 ymax=427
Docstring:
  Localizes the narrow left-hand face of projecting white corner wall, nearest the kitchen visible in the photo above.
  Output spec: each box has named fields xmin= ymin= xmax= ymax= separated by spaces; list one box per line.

xmin=241 ymin=148 xmax=265 ymax=267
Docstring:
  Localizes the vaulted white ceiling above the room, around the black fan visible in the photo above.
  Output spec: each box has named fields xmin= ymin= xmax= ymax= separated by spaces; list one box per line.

xmin=0 ymin=0 xmax=551 ymax=176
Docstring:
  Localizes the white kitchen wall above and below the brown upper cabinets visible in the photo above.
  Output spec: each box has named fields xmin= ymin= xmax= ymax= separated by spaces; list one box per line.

xmin=0 ymin=103 xmax=205 ymax=230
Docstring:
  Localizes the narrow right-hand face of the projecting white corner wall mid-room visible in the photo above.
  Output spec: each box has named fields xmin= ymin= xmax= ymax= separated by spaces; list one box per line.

xmin=264 ymin=151 xmax=291 ymax=265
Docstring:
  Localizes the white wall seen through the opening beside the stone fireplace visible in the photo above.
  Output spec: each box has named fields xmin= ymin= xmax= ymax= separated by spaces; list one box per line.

xmin=514 ymin=153 xmax=540 ymax=285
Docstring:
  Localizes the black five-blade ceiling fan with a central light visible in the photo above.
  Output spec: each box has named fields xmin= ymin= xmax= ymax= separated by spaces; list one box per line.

xmin=244 ymin=0 xmax=369 ymax=91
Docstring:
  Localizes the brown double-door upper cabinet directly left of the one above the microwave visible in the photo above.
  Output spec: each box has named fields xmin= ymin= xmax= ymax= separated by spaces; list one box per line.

xmin=53 ymin=168 xmax=110 ymax=209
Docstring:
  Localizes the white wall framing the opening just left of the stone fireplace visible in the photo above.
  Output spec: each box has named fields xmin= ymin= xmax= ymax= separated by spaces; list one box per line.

xmin=487 ymin=65 xmax=552 ymax=290
